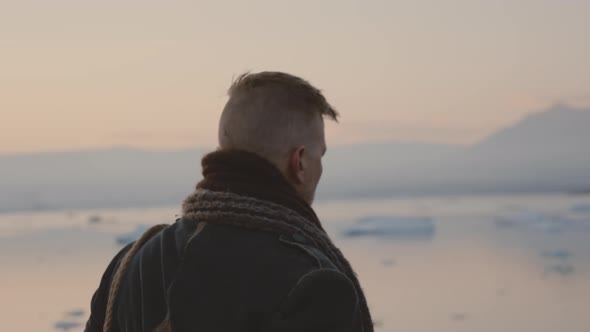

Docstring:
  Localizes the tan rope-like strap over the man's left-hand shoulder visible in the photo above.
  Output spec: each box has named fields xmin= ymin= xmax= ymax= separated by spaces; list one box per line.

xmin=103 ymin=224 xmax=168 ymax=332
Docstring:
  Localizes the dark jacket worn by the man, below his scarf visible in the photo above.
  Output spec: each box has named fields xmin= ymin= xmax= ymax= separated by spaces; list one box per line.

xmin=85 ymin=219 xmax=359 ymax=332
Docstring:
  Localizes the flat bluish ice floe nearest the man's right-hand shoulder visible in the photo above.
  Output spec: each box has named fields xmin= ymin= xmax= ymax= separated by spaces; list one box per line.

xmin=342 ymin=216 xmax=435 ymax=239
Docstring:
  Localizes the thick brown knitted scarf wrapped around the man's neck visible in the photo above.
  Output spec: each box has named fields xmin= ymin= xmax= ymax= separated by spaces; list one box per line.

xmin=182 ymin=150 xmax=373 ymax=332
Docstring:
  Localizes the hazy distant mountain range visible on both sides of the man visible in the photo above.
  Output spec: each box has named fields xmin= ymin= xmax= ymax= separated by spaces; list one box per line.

xmin=0 ymin=105 xmax=590 ymax=212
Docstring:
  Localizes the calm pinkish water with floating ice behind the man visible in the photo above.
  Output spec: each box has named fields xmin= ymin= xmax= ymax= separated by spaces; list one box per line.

xmin=0 ymin=195 xmax=590 ymax=332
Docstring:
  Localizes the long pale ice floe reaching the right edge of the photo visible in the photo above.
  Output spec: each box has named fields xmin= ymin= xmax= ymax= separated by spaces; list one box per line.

xmin=495 ymin=211 xmax=590 ymax=233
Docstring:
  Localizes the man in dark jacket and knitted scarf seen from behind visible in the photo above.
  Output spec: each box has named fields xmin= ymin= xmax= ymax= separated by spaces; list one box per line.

xmin=86 ymin=72 xmax=373 ymax=332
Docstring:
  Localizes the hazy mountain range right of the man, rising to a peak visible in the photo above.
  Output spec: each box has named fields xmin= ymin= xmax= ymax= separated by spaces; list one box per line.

xmin=322 ymin=105 xmax=590 ymax=196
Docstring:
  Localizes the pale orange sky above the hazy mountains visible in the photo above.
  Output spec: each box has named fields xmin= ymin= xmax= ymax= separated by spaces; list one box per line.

xmin=0 ymin=0 xmax=590 ymax=153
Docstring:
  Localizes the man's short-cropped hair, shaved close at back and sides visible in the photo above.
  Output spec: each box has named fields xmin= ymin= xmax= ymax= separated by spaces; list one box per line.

xmin=218 ymin=72 xmax=338 ymax=164
